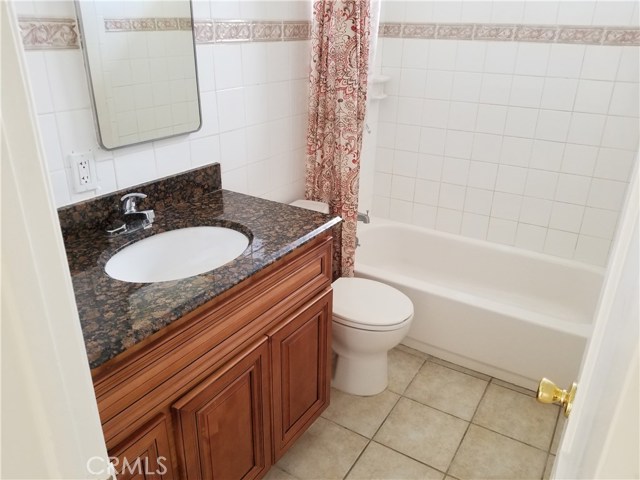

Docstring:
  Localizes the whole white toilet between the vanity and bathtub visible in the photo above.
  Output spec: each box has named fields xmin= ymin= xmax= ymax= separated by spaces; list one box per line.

xmin=291 ymin=200 xmax=413 ymax=396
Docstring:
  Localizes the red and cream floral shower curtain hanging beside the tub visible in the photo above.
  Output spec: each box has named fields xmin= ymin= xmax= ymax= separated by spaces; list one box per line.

xmin=306 ymin=0 xmax=371 ymax=277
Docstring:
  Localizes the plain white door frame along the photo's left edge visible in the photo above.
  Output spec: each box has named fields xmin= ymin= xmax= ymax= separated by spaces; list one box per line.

xmin=0 ymin=2 xmax=108 ymax=479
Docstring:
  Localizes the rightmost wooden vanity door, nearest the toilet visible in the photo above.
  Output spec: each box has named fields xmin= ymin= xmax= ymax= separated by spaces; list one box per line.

xmin=270 ymin=290 xmax=332 ymax=461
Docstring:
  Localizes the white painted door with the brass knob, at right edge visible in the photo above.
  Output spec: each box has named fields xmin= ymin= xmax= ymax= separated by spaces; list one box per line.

xmin=552 ymin=170 xmax=640 ymax=479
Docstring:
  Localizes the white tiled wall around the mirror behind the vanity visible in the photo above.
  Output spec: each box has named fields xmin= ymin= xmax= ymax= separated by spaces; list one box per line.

xmin=16 ymin=0 xmax=311 ymax=206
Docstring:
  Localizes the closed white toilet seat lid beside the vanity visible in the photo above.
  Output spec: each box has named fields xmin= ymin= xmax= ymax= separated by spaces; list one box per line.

xmin=333 ymin=278 xmax=413 ymax=331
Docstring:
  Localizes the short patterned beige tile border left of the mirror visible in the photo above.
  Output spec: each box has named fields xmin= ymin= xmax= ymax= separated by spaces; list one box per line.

xmin=19 ymin=17 xmax=80 ymax=50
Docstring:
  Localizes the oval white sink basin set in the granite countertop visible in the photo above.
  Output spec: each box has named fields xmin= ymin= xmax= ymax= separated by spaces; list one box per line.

xmin=104 ymin=227 xmax=249 ymax=283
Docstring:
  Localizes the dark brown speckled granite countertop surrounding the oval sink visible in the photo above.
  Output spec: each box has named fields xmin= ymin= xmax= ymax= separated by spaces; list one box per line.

xmin=63 ymin=167 xmax=340 ymax=368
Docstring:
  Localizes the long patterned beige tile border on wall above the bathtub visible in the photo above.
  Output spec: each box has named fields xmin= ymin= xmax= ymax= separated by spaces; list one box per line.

xmin=379 ymin=23 xmax=640 ymax=46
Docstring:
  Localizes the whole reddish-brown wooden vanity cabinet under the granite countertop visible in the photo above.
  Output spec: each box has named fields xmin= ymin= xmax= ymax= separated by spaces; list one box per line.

xmin=93 ymin=234 xmax=332 ymax=480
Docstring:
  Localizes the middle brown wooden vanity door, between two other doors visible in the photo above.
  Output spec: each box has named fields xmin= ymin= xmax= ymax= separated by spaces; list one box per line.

xmin=172 ymin=337 xmax=271 ymax=480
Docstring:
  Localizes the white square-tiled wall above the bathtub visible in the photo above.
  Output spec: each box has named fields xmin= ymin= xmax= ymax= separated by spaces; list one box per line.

xmin=364 ymin=0 xmax=639 ymax=265
